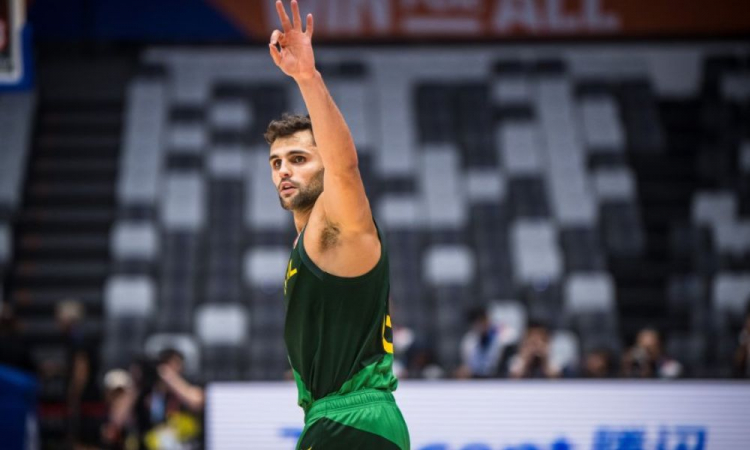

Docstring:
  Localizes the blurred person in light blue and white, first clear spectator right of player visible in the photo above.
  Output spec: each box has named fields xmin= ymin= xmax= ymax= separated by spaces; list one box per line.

xmin=456 ymin=308 xmax=507 ymax=378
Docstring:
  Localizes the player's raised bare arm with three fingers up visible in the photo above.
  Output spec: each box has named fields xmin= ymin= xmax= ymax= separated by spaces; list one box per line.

xmin=269 ymin=0 xmax=376 ymax=234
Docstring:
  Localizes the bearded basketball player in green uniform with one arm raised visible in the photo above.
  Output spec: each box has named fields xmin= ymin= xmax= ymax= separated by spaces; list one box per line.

xmin=265 ymin=0 xmax=409 ymax=450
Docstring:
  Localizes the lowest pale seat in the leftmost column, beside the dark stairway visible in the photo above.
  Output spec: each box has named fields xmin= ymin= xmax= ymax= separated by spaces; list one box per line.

xmin=104 ymin=275 xmax=156 ymax=319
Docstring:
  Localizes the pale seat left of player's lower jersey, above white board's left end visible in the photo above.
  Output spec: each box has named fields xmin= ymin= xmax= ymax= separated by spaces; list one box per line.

xmin=195 ymin=304 xmax=250 ymax=346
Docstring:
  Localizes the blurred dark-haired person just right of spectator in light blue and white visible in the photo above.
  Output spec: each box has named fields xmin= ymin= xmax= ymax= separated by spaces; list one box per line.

xmin=501 ymin=321 xmax=563 ymax=378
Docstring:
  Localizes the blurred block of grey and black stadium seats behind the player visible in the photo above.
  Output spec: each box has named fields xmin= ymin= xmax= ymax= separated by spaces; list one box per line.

xmin=98 ymin=47 xmax=750 ymax=379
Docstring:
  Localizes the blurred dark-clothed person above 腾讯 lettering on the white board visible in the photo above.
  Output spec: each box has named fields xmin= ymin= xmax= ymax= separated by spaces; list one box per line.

xmin=622 ymin=328 xmax=682 ymax=378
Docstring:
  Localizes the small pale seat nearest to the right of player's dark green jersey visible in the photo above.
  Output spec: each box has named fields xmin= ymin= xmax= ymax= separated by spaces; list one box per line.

xmin=424 ymin=245 xmax=476 ymax=285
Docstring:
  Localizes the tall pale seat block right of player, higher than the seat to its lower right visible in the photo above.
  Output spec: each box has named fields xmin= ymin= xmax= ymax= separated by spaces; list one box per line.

xmin=511 ymin=220 xmax=563 ymax=284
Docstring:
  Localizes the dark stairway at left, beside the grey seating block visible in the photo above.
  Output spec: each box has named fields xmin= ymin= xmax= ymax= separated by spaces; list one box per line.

xmin=8 ymin=53 xmax=132 ymax=448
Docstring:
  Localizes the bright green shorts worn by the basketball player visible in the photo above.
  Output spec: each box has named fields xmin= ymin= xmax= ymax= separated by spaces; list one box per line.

xmin=297 ymin=389 xmax=409 ymax=450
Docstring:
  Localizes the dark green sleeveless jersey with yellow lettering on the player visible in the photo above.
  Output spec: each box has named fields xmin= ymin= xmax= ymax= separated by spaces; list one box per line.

xmin=284 ymin=223 xmax=397 ymax=412
